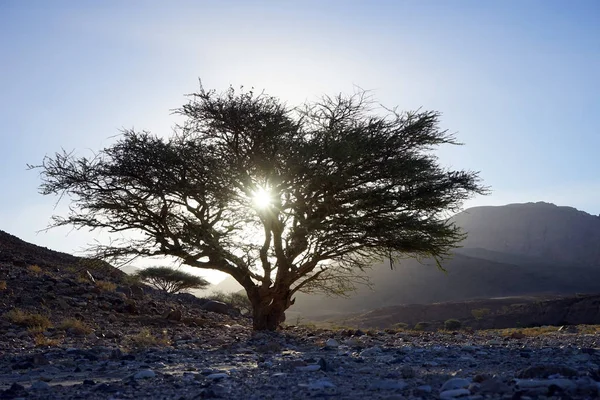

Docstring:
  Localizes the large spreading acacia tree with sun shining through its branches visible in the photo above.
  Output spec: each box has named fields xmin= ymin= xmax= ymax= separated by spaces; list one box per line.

xmin=31 ymin=88 xmax=486 ymax=330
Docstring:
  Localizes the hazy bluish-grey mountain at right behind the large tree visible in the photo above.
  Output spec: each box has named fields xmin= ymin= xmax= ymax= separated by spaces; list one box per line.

xmin=210 ymin=203 xmax=600 ymax=318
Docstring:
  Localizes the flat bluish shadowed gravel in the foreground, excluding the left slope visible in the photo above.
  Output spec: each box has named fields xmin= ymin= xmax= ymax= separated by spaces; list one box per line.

xmin=0 ymin=321 xmax=600 ymax=400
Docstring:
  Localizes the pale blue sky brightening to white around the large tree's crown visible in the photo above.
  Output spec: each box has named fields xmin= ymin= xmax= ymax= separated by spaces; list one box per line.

xmin=0 ymin=0 xmax=600 ymax=282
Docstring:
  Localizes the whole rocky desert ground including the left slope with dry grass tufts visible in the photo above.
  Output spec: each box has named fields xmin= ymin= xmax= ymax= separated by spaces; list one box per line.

xmin=0 ymin=230 xmax=600 ymax=400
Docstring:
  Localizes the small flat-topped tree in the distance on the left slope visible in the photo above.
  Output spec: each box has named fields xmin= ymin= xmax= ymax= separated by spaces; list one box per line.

xmin=135 ymin=267 xmax=209 ymax=293
